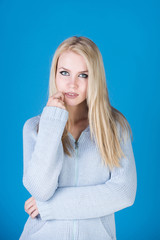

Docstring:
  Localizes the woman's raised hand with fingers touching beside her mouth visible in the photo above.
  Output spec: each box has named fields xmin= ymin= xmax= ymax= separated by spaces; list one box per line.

xmin=47 ymin=91 xmax=66 ymax=110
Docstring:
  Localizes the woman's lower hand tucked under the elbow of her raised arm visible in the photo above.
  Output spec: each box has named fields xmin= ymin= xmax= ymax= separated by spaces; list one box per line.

xmin=24 ymin=197 xmax=39 ymax=218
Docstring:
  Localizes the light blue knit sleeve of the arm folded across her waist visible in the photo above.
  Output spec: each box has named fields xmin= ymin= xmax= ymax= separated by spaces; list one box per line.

xmin=36 ymin=128 xmax=137 ymax=220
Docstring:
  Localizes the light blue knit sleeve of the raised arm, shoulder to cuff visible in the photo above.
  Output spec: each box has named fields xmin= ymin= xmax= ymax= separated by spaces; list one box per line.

xmin=23 ymin=106 xmax=68 ymax=201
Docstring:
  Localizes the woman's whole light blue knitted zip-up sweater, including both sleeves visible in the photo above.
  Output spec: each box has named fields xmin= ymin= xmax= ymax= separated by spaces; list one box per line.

xmin=20 ymin=106 xmax=137 ymax=240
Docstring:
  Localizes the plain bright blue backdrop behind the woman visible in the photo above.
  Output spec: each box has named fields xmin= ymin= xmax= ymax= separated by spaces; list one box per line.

xmin=0 ymin=0 xmax=160 ymax=240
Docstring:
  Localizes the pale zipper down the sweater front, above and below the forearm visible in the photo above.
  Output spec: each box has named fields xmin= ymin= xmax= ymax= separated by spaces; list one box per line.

xmin=73 ymin=141 xmax=78 ymax=240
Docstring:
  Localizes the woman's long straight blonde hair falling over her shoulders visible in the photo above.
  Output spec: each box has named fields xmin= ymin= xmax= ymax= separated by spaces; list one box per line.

xmin=49 ymin=36 xmax=133 ymax=169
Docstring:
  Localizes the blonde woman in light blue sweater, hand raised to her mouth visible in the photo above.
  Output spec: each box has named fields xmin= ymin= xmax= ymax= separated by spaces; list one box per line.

xmin=20 ymin=36 xmax=137 ymax=240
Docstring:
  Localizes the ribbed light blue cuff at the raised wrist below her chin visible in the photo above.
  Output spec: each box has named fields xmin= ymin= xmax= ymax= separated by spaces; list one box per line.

xmin=41 ymin=106 xmax=69 ymax=122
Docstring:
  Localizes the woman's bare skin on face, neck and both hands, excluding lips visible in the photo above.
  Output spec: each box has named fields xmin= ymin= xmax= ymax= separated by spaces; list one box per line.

xmin=25 ymin=51 xmax=89 ymax=218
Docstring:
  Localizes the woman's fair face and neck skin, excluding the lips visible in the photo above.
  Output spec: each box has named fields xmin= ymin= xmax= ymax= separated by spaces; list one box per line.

xmin=56 ymin=51 xmax=88 ymax=126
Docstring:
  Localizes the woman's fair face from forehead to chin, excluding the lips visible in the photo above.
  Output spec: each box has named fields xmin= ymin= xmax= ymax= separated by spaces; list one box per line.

xmin=56 ymin=51 xmax=88 ymax=106
